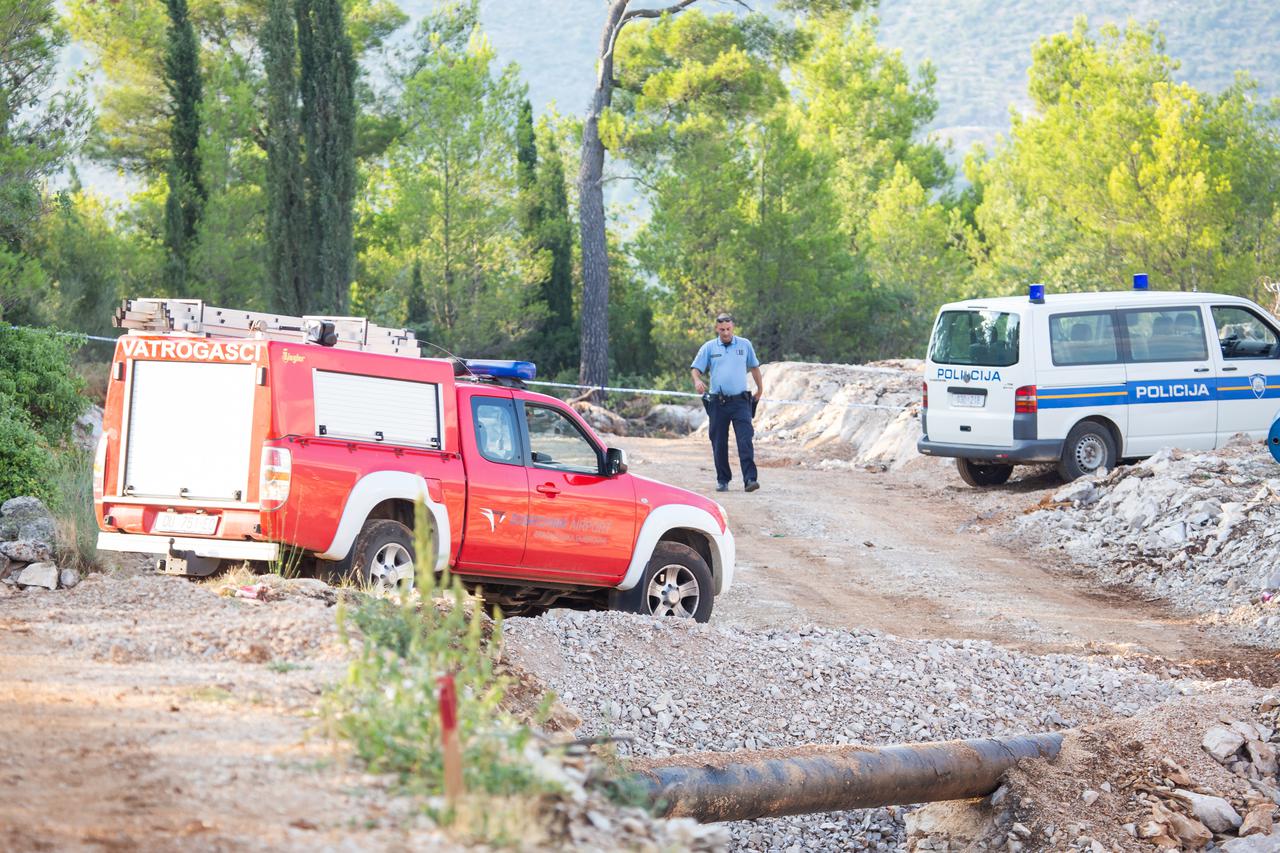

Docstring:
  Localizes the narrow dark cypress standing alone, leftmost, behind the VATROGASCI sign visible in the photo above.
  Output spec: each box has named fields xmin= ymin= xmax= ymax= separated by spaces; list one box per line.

xmin=164 ymin=0 xmax=206 ymax=293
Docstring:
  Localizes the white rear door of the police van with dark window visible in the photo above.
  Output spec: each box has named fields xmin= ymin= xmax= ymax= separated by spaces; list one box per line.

xmin=925 ymin=307 xmax=1033 ymax=447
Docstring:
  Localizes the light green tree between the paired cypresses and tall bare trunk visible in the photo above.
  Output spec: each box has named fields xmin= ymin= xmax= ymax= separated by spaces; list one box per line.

xmin=360 ymin=3 xmax=547 ymax=356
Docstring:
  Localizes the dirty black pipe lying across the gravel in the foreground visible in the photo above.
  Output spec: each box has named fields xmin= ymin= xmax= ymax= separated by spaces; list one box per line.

xmin=635 ymin=733 xmax=1062 ymax=824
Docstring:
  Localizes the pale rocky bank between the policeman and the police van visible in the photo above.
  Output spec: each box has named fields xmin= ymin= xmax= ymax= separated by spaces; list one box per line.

xmin=755 ymin=360 xmax=928 ymax=470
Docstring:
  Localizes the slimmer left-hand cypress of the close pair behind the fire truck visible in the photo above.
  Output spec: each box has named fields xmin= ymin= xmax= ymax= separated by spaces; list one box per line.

xmin=259 ymin=0 xmax=308 ymax=314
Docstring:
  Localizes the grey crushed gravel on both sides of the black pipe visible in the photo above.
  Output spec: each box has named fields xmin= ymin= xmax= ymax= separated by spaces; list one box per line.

xmin=503 ymin=611 xmax=1204 ymax=850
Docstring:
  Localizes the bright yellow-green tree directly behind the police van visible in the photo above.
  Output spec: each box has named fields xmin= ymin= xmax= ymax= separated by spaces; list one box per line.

xmin=966 ymin=18 xmax=1280 ymax=293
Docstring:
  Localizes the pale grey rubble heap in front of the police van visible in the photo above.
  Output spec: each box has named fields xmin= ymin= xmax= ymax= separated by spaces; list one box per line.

xmin=1014 ymin=441 xmax=1280 ymax=647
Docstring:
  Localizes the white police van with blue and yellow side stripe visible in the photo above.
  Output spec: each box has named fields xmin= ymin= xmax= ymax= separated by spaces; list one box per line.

xmin=916 ymin=274 xmax=1280 ymax=485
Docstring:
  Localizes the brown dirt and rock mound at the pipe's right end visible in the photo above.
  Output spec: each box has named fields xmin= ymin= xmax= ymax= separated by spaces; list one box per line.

xmin=906 ymin=683 xmax=1280 ymax=853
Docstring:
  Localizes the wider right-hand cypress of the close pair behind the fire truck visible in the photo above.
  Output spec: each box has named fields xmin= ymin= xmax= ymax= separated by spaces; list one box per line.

xmin=297 ymin=0 xmax=356 ymax=314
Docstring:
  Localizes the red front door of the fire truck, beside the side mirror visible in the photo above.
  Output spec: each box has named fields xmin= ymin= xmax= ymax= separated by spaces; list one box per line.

xmin=524 ymin=401 xmax=636 ymax=583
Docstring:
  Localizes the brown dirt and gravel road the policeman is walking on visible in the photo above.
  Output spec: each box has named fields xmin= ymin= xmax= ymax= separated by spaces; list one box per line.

xmin=616 ymin=438 xmax=1276 ymax=675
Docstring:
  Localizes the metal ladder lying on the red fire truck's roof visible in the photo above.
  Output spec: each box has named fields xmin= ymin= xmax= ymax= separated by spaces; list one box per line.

xmin=111 ymin=298 xmax=422 ymax=359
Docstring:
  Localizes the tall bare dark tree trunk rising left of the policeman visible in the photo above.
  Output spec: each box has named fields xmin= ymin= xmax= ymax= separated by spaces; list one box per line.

xmin=577 ymin=0 xmax=630 ymax=402
